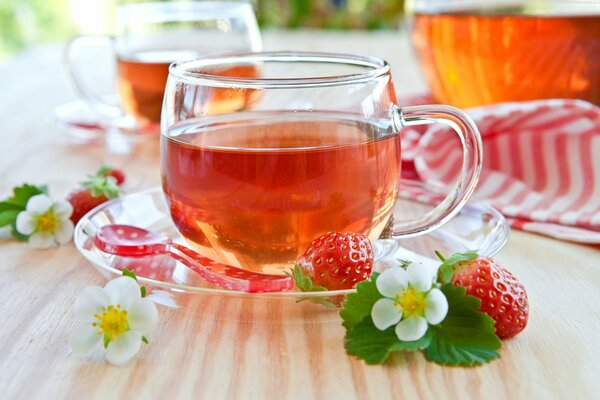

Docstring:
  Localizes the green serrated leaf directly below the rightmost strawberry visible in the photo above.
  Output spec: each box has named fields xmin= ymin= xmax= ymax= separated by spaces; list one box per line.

xmin=425 ymin=284 xmax=502 ymax=366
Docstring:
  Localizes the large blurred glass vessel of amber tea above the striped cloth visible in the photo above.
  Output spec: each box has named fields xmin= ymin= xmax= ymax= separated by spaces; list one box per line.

xmin=406 ymin=0 xmax=600 ymax=107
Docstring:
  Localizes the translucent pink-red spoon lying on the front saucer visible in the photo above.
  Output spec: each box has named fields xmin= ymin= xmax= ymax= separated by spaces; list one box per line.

xmin=95 ymin=225 xmax=294 ymax=293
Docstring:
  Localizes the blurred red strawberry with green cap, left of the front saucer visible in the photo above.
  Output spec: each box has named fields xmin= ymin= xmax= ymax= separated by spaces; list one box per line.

xmin=67 ymin=176 xmax=119 ymax=224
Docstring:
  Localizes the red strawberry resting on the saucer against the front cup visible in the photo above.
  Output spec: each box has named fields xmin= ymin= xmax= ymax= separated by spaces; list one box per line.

xmin=294 ymin=232 xmax=373 ymax=291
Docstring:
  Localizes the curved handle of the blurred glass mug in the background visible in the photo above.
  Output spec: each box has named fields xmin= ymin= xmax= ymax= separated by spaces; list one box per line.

xmin=63 ymin=35 xmax=123 ymax=118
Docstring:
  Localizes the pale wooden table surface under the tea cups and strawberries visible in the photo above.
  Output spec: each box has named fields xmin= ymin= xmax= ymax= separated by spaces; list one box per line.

xmin=0 ymin=32 xmax=600 ymax=399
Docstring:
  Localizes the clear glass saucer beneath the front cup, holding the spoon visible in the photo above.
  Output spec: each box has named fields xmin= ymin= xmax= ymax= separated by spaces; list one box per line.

xmin=74 ymin=181 xmax=508 ymax=322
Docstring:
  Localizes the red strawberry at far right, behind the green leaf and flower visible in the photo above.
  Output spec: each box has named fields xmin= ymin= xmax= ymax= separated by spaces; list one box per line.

xmin=440 ymin=256 xmax=529 ymax=339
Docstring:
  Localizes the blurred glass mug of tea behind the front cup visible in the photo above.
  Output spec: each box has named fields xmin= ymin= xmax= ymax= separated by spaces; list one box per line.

xmin=65 ymin=1 xmax=262 ymax=128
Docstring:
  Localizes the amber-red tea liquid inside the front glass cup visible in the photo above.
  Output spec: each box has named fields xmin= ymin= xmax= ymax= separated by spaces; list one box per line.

xmin=161 ymin=113 xmax=400 ymax=272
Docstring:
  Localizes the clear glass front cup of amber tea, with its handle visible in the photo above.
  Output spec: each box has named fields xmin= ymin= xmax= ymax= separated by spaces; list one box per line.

xmin=161 ymin=52 xmax=482 ymax=272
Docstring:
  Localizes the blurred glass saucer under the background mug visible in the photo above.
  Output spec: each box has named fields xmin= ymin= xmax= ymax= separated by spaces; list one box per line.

xmin=54 ymin=100 xmax=160 ymax=153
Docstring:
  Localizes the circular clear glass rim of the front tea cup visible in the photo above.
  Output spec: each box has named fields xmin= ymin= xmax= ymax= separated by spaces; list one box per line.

xmin=169 ymin=51 xmax=390 ymax=89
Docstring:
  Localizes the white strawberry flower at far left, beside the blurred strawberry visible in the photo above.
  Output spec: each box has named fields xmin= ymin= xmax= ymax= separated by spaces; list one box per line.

xmin=15 ymin=194 xmax=73 ymax=249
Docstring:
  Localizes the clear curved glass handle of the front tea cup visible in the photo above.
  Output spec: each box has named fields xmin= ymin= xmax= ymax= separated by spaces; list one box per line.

xmin=392 ymin=105 xmax=483 ymax=237
